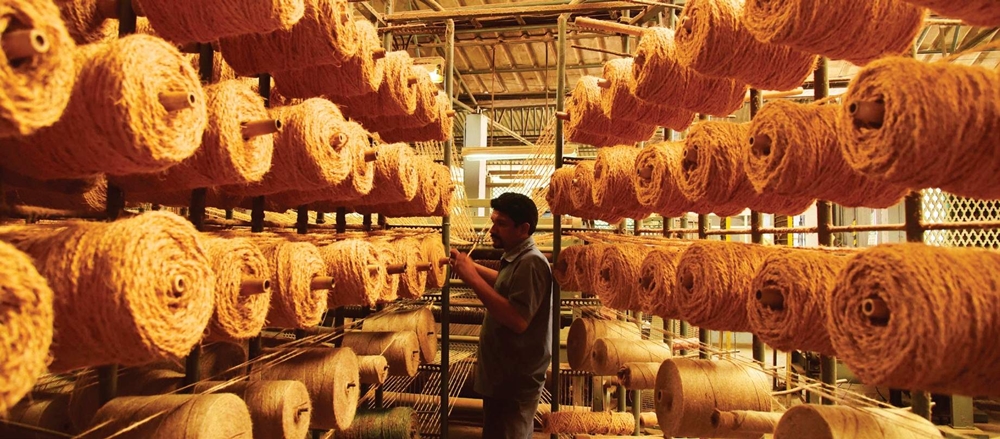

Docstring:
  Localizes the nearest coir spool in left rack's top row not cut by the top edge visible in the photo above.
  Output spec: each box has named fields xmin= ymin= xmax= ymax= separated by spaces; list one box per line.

xmin=274 ymin=20 xmax=385 ymax=99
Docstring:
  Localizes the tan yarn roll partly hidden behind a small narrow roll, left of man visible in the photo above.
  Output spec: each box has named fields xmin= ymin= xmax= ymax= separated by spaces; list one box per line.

xmin=342 ymin=331 xmax=420 ymax=377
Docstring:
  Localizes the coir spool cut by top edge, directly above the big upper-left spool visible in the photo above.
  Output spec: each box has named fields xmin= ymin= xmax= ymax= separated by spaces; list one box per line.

xmin=139 ymin=0 xmax=305 ymax=43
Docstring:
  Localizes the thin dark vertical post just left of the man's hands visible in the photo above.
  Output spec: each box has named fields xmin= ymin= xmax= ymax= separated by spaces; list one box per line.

xmin=441 ymin=19 xmax=455 ymax=439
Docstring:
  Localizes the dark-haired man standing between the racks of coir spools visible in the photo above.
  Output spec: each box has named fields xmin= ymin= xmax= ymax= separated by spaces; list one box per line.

xmin=451 ymin=193 xmax=552 ymax=439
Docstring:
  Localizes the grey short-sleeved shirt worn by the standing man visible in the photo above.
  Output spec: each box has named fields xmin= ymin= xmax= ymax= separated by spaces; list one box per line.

xmin=475 ymin=237 xmax=552 ymax=400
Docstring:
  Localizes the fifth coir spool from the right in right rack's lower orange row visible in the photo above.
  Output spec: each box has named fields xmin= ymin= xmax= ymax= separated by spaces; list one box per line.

xmin=594 ymin=243 xmax=652 ymax=311
